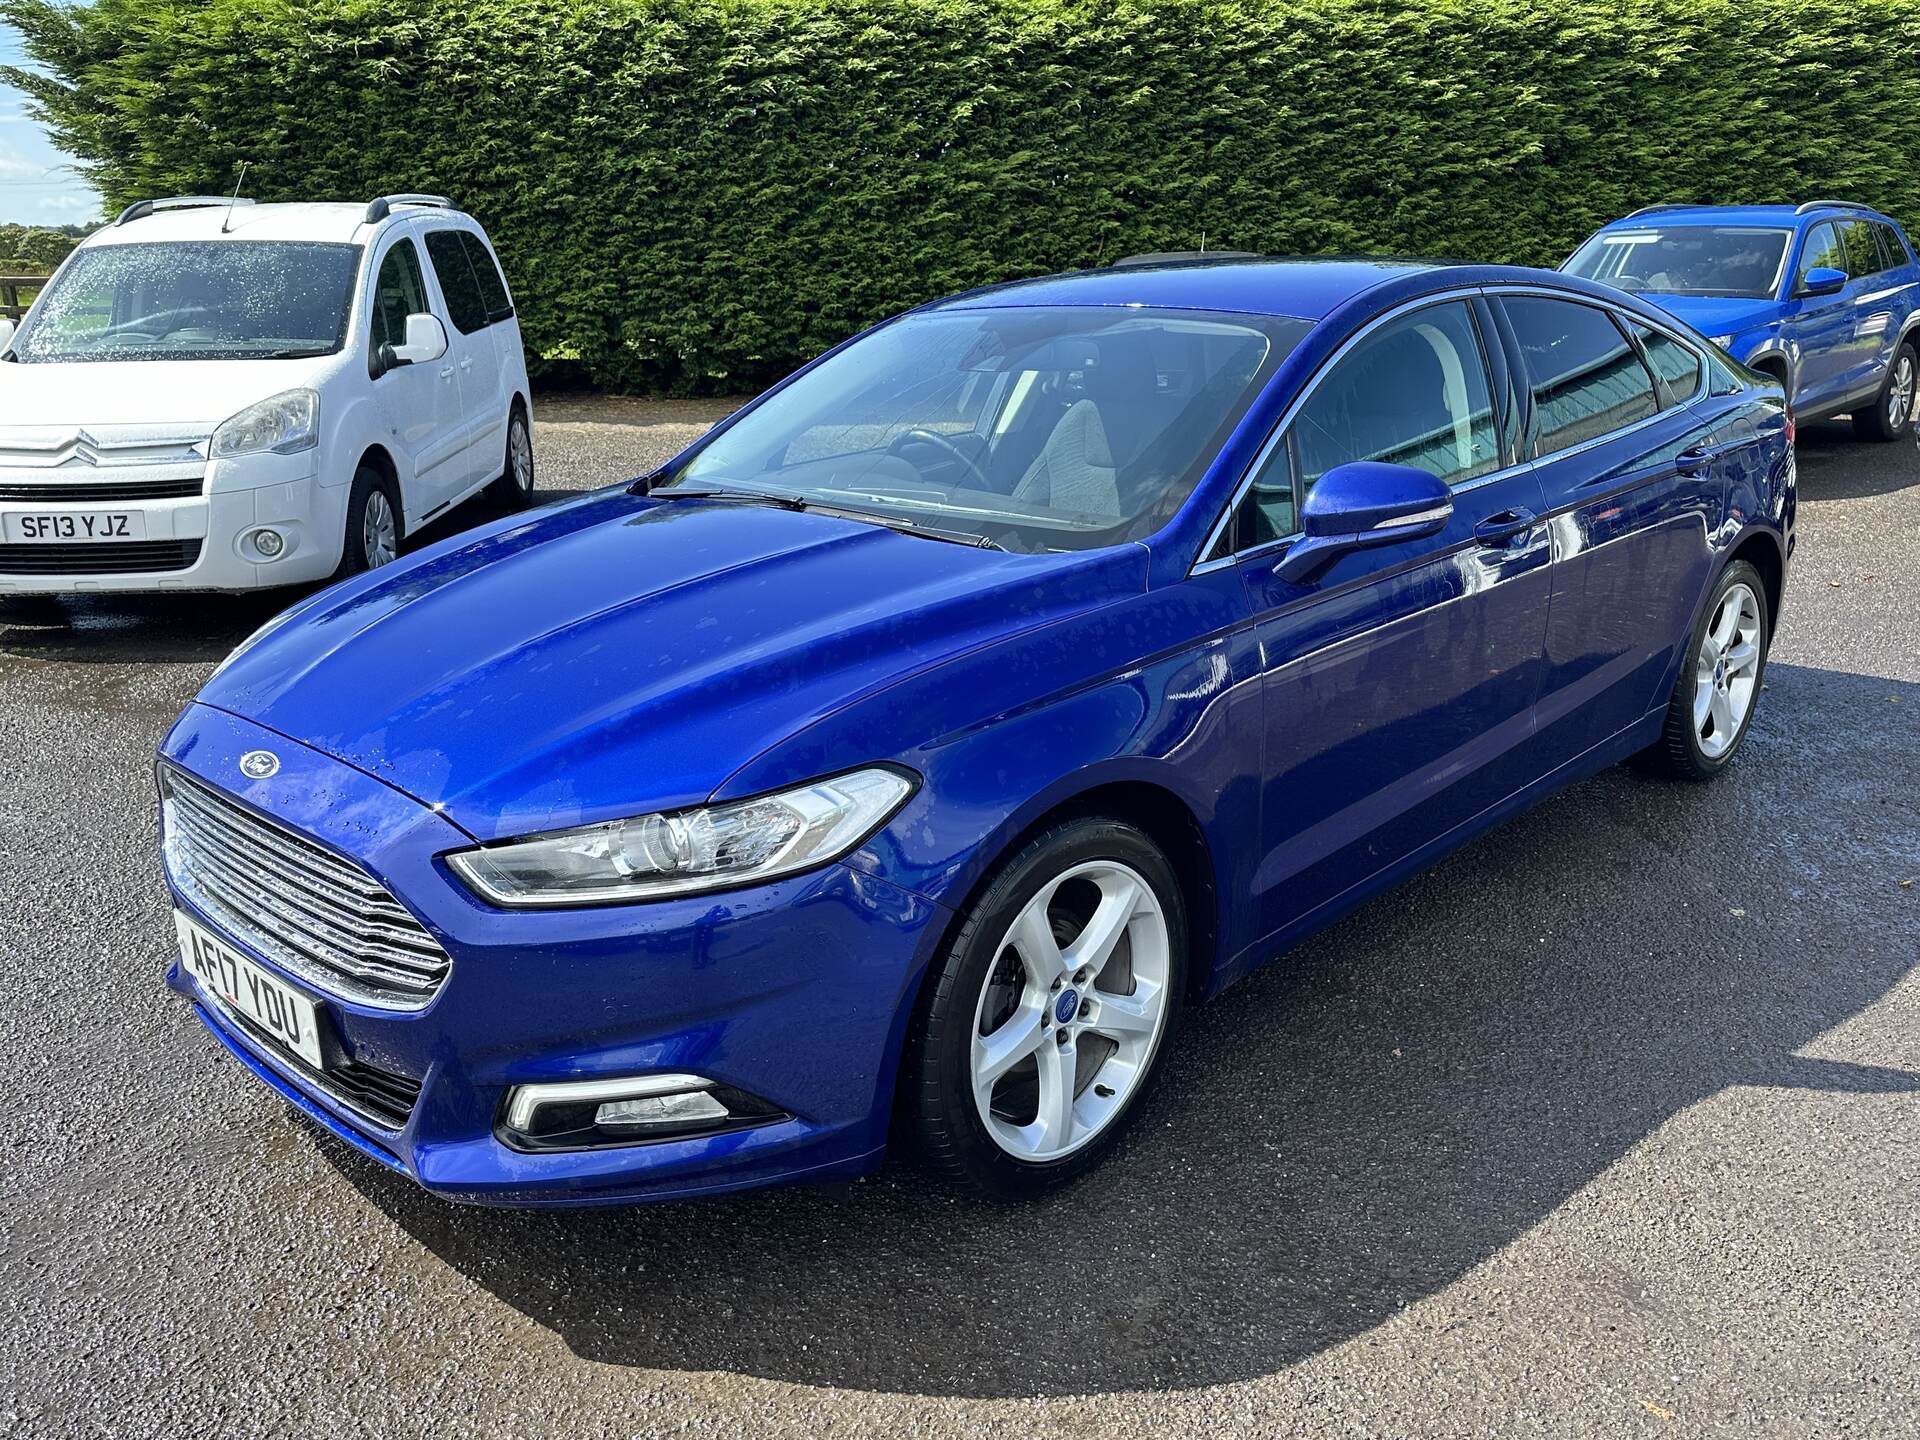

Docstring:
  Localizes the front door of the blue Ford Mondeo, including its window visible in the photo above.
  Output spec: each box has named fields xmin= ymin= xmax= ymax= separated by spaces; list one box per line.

xmin=1236 ymin=300 xmax=1549 ymax=933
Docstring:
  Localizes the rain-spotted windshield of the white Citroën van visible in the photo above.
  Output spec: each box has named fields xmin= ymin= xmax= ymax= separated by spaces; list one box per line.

xmin=13 ymin=240 xmax=361 ymax=365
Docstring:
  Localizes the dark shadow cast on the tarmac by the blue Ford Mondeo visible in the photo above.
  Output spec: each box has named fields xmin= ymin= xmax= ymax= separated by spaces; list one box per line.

xmin=326 ymin=664 xmax=1920 ymax=1398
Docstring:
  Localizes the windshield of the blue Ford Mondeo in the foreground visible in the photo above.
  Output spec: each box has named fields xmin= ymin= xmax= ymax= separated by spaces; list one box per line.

xmin=660 ymin=307 xmax=1311 ymax=551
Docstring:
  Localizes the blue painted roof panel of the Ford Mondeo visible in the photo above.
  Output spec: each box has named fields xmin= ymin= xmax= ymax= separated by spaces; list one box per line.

xmin=935 ymin=255 xmax=1450 ymax=321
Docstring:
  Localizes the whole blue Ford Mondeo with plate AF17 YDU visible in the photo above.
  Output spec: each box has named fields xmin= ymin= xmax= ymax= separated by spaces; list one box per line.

xmin=159 ymin=259 xmax=1795 ymax=1204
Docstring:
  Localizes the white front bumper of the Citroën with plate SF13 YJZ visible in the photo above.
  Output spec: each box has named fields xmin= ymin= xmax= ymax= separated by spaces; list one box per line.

xmin=0 ymin=451 xmax=346 ymax=595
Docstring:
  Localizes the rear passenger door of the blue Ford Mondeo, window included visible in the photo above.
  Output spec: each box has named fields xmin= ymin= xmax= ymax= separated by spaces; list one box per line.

xmin=1498 ymin=294 xmax=1740 ymax=772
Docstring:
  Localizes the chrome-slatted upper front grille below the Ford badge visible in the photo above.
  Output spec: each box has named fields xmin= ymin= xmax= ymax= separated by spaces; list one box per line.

xmin=161 ymin=766 xmax=453 ymax=1010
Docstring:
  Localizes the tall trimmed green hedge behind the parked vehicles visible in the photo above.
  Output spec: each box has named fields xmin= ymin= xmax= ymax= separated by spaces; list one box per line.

xmin=0 ymin=0 xmax=1920 ymax=390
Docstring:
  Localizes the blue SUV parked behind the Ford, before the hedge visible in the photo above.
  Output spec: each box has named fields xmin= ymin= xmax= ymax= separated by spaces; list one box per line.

xmin=1561 ymin=200 xmax=1920 ymax=440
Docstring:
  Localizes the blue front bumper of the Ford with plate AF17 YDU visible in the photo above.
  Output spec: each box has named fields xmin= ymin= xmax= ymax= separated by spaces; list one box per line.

xmin=161 ymin=705 xmax=945 ymax=1206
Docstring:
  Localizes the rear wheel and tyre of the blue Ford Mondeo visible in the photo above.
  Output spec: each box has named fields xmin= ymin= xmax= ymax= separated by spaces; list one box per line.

xmin=1644 ymin=561 xmax=1770 ymax=780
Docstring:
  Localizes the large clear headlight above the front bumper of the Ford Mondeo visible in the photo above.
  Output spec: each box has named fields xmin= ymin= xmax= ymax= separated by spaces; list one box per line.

xmin=447 ymin=768 xmax=914 ymax=906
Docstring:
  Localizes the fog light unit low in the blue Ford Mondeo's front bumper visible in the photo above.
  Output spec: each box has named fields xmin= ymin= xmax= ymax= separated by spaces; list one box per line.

xmin=499 ymin=1075 xmax=787 ymax=1150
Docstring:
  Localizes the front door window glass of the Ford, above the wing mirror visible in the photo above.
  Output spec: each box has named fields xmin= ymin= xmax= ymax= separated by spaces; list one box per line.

xmin=1290 ymin=301 xmax=1500 ymax=503
